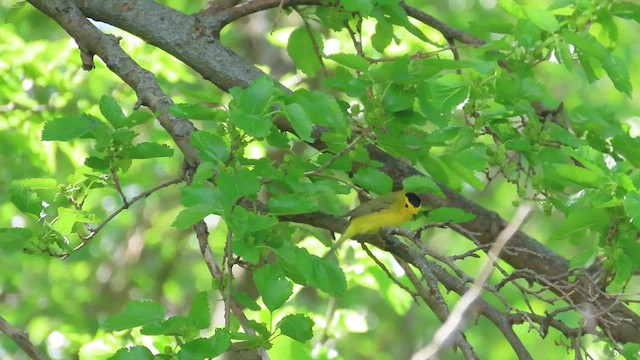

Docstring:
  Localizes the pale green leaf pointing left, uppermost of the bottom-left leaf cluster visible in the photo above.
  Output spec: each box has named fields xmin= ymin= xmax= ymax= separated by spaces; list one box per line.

xmin=103 ymin=301 xmax=165 ymax=331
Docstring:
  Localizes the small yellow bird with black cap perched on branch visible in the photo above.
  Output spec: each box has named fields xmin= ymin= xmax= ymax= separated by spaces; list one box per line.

xmin=325 ymin=191 xmax=422 ymax=257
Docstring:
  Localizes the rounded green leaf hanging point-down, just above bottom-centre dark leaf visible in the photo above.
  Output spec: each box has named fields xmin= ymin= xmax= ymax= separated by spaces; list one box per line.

xmin=253 ymin=264 xmax=293 ymax=311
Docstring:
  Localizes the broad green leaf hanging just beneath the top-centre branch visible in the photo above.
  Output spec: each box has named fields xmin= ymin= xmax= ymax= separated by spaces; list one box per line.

xmin=287 ymin=26 xmax=324 ymax=76
